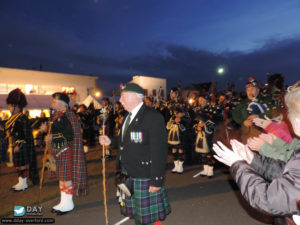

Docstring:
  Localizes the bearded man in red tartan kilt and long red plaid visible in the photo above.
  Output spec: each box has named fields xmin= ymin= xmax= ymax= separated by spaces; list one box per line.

xmin=43 ymin=92 xmax=87 ymax=215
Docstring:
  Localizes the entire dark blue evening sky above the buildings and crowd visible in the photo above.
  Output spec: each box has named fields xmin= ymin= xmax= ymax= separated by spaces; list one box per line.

xmin=0 ymin=0 xmax=300 ymax=93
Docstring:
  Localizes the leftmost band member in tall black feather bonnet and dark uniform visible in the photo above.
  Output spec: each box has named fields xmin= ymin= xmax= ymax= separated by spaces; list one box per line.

xmin=5 ymin=88 xmax=39 ymax=191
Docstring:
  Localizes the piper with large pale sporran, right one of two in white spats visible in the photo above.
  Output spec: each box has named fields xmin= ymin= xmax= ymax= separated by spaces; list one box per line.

xmin=194 ymin=114 xmax=215 ymax=178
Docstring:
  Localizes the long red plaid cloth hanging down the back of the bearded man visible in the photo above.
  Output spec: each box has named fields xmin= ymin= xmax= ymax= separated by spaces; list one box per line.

xmin=66 ymin=110 xmax=88 ymax=196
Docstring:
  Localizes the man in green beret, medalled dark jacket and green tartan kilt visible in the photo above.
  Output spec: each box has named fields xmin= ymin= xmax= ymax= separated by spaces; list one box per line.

xmin=99 ymin=83 xmax=171 ymax=225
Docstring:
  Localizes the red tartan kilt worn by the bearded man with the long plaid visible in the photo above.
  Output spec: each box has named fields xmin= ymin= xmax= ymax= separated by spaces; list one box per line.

xmin=56 ymin=147 xmax=73 ymax=181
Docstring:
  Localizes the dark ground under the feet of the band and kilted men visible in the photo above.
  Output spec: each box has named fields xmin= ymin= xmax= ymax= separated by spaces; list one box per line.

xmin=0 ymin=147 xmax=272 ymax=225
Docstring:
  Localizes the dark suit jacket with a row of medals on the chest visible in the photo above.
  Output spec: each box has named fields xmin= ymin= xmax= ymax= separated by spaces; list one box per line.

xmin=117 ymin=104 xmax=168 ymax=187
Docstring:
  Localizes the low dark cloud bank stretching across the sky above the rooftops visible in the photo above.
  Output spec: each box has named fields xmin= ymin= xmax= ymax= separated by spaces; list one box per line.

xmin=0 ymin=22 xmax=300 ymax=92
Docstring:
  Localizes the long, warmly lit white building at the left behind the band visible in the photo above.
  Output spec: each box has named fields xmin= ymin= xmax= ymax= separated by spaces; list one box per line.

xmin=0 ymin=67 xmax=98 ymax=117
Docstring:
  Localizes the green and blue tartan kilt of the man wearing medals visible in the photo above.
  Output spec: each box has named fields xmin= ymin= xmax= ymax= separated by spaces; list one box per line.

xmin=121 ymin=178 xmax=171 ymax=224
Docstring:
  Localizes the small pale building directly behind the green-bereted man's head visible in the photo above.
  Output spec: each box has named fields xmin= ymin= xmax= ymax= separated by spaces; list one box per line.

xmin=131 ymin=75 xmax=167 ymax=99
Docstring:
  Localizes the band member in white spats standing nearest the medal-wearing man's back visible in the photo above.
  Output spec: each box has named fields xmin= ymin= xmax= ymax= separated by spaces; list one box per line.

xmin=167 ymin=107 xmax=186 ymax=173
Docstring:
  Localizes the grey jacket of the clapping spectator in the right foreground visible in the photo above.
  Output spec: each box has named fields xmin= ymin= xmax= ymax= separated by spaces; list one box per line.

xmin=230 ymin=141 xmax=300 ymax=223
